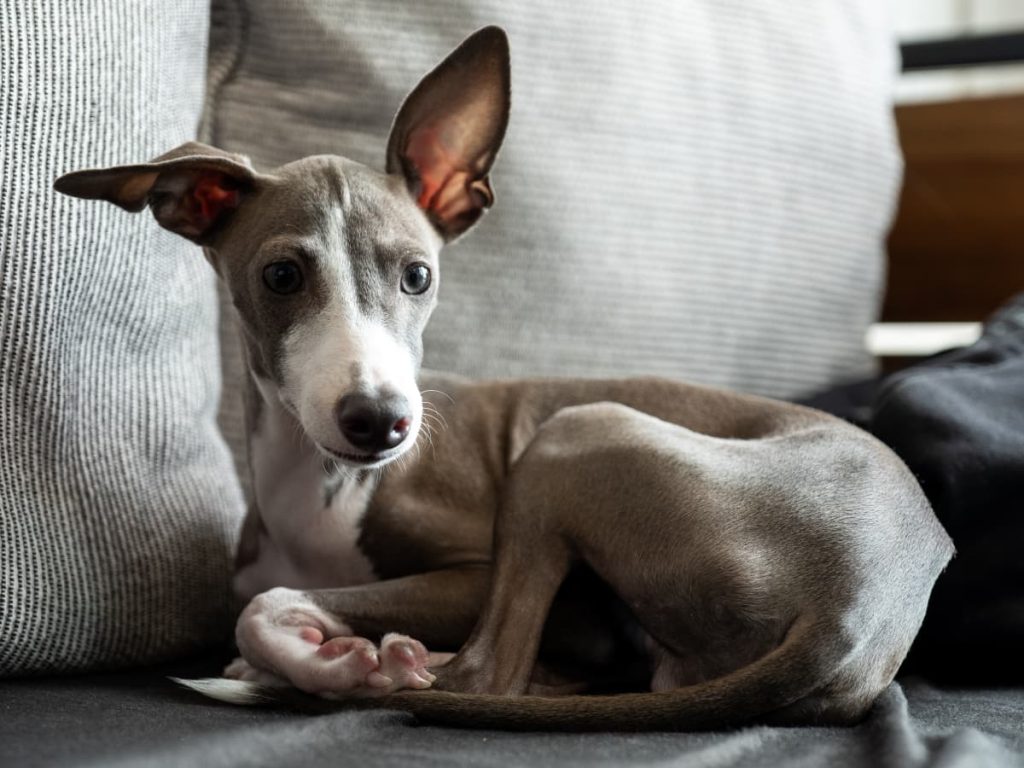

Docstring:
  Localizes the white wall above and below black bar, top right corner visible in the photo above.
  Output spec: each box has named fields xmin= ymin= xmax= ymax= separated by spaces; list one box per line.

xmin=893 ymin=0 xmax=1024 ymax=102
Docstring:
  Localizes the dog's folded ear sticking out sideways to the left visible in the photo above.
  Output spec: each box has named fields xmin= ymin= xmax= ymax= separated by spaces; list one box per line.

xmin=53 ymin=141 xmax=256 ymax=243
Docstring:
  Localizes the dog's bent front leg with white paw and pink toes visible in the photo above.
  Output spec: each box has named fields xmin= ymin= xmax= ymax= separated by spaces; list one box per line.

xmin=234 ymin=566 xmax=490 ymax=697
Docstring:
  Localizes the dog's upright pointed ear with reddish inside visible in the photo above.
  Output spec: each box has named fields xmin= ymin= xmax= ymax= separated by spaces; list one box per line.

xmin=387 ymin=27 xmax=510 ymax=240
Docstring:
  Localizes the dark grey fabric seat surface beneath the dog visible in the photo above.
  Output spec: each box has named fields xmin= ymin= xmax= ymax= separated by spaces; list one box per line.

xmin=0 ymin=665 xmax=1024 ymax=768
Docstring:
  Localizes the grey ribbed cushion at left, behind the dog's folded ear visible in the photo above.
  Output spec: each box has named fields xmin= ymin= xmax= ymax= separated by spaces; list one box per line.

xmin=0 ymin=0 xmax=241 ymax=675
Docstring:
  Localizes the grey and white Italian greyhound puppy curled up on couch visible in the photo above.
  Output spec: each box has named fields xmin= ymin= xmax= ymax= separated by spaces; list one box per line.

xmin=56 ymin=28 xmax=952 ymax=729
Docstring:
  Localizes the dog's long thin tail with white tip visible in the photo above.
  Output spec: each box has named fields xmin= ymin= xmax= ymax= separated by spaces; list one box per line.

xmin=177 ymin=618 xmax=852 ymax=731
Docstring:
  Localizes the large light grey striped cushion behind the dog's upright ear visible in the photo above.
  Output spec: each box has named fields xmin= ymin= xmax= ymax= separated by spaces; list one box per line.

xmin=203 ymin=0 xmax=900 ymax=415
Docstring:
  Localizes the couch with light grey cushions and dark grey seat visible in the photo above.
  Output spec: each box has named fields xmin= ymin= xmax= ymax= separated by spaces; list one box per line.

xmin=0 ymin=0 xmax=1024 ymax=766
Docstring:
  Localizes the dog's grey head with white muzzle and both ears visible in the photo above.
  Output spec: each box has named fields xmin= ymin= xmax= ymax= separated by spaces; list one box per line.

xmin=54 ymin=27 xmax=509 ymax=467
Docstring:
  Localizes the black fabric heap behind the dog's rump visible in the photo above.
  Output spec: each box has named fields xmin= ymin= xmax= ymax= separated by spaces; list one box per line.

xmin=808 ymin=294 xmax=1024 ymax=684
